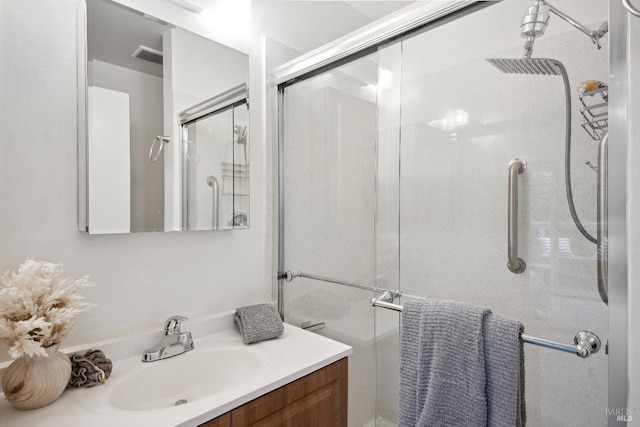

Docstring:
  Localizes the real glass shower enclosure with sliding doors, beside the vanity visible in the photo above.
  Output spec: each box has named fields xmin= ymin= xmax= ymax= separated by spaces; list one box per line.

xmin=272 ymin=0 xmax=609 ymax=427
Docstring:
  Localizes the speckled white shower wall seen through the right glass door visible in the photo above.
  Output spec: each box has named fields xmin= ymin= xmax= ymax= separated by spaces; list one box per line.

xmin=400 ymin=2 xmax=608 ymax=425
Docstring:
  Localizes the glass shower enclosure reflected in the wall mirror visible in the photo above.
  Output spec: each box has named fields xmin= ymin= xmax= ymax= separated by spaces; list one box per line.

xmin=180 ymin=85 xmax=249 ymax=230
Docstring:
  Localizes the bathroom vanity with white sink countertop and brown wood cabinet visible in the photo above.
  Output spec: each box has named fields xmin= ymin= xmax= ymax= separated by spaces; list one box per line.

xmin=0 ymin=312 xmax=352 ymax=427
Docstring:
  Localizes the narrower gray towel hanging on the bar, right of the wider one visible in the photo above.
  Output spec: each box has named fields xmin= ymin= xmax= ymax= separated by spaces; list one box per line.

xmin=484 ymin=313 xmax=526 ymax=427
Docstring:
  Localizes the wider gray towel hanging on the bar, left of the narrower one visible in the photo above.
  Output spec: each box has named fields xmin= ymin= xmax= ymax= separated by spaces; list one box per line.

xmin=398 ymin=299 xmax=489 ymax=427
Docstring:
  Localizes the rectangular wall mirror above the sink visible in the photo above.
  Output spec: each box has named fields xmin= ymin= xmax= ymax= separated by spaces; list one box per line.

xmin=78 ymin=0 xmax=249 ymax=234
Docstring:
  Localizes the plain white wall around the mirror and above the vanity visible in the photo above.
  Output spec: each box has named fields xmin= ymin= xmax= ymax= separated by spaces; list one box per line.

xmin=0 ymin=0 xmax=271 ymax=360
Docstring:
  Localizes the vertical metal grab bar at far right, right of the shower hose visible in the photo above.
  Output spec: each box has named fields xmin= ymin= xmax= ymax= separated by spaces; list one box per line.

xmin=596 ymin=133 xmax=609 ymax=304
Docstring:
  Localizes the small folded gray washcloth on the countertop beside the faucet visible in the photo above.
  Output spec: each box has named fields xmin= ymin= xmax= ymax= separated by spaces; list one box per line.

xmin=233 ymin=304 xmax=284 ymax=344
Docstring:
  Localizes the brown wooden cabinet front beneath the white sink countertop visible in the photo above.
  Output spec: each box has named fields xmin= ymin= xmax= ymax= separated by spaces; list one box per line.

xmin=200 ymin=357 xmax=348 ymax=427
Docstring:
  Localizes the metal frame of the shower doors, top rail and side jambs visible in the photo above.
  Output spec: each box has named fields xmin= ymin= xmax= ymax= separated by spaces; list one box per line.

xmin=269 ymin=1 xmax=630 ymax=426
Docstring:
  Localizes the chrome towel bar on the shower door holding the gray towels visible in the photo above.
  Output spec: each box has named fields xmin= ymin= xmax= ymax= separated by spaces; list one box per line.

xmin=371 ymin=291 xmax=602 ymax=359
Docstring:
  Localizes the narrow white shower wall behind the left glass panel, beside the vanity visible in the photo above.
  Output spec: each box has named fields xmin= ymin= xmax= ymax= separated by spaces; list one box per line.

xmin=284 ymin=71 xmax=376 ymax=426
